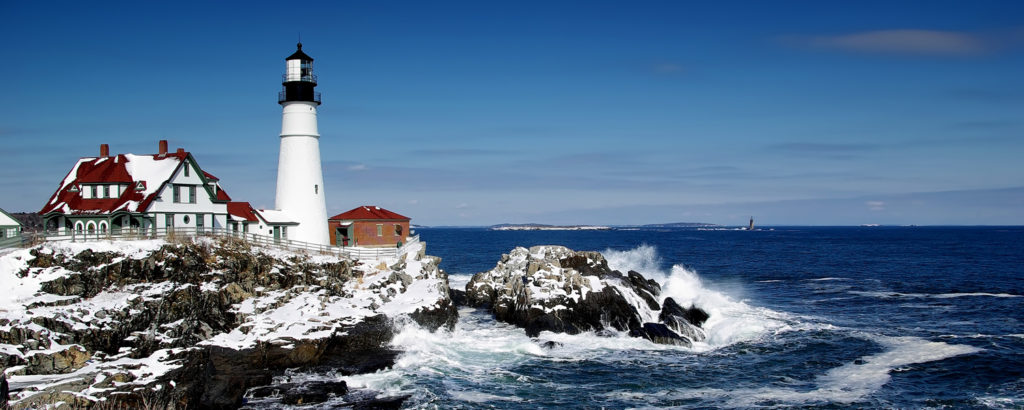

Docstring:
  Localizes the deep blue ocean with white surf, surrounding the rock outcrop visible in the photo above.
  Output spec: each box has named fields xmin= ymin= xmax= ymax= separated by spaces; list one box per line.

xmin=345 ymin=228 xmax=1024 ymax=408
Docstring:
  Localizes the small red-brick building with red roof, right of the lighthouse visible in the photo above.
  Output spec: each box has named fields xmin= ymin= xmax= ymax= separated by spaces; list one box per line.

xmin=327 ymin=205 xmax=410 ymax=247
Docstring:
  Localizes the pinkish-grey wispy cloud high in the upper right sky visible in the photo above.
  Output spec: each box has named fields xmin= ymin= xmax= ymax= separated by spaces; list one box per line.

xmin=785 ymin=29 xmax=993 ymax=56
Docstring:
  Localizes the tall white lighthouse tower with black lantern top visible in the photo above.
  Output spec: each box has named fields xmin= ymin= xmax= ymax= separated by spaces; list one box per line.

xmin=275 ymin=43 xmax=330 ymax=245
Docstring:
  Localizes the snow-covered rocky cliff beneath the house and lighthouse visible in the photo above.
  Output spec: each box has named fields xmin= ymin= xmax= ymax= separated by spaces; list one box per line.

xmin=0 ymin=238 xmax=458 ymax=408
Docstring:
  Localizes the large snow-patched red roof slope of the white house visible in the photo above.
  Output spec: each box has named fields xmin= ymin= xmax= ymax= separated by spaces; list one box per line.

xmin=39 ymin=151 xmax=230 ymax=215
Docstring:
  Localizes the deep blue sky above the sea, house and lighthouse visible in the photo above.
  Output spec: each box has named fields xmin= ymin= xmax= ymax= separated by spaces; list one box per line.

xmin=0 ymin=1 xmax=1024 ymax=226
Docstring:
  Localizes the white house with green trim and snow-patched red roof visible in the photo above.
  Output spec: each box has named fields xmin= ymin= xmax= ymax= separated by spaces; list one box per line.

xmin=39 ymin=140 xmax=287 ymax=238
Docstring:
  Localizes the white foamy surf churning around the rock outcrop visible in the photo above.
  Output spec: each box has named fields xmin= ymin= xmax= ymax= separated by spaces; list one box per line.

xmin=344 ymin=245 xmax=978 ymax=407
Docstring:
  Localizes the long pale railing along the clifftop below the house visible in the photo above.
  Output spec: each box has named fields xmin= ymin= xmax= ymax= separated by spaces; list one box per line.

xmin=27 ymin=228 xmax=420 ymax=259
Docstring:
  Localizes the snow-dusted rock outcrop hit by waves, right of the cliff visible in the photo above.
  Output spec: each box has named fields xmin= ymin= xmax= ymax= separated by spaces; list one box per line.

xmin=466 ymin=246 xmax=708 ymax=346
